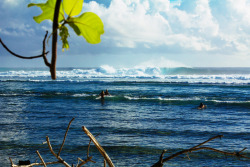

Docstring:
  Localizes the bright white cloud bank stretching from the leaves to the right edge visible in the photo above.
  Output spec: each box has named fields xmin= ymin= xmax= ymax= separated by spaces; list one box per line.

xmin=82 ymin=0 xmax=250 ymax=52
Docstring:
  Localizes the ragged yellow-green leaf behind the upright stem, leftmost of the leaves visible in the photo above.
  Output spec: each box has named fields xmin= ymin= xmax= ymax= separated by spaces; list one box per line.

xmin=28 ymin=0 xmax=64 ymax=23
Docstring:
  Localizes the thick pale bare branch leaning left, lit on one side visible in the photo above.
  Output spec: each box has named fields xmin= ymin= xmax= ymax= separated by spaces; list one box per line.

xmin=82 ymin=126 xmax=114 ymax=167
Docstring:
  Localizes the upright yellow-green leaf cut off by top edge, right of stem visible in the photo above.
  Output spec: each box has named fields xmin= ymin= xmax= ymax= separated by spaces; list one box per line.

xmin=63 ymin=0 xmax=83 ymax=17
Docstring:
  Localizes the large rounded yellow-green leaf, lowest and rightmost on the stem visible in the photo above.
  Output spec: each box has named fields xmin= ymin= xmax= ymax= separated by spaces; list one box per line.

xmin=68 ymin=12 xmax=104 ymax=44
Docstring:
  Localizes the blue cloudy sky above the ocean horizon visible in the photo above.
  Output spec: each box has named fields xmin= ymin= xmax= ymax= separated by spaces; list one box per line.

xmin=0 ymin=0 xmax=250 ymax=67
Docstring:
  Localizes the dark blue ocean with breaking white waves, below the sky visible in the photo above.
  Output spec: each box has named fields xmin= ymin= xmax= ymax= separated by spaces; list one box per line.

xmin=0 ymin=65 xmax=250 ymax=167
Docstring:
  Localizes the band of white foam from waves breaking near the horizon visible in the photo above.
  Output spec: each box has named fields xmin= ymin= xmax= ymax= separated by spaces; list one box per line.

xmin=0 ymin=65 xmax=250 ymax=84
